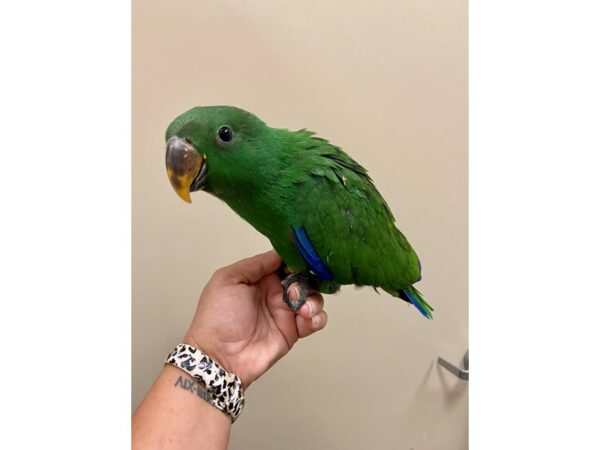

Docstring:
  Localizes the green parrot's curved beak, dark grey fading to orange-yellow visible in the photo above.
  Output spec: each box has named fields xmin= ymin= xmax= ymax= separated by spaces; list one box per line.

xmin=166 ymin=136 xmax=206 ymax=203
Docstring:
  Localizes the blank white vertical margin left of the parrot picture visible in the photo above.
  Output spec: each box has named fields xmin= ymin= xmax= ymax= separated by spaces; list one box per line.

xmin=0 ymin=0 xmax=131 ymax=450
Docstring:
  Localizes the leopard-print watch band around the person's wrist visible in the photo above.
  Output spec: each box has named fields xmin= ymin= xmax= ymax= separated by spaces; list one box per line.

xmin=165 ymin=344 xmax=245 ymax=423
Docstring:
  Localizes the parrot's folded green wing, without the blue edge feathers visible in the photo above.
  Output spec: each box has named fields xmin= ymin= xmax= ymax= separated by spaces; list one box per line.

xmin=293 ymin=132 xmax=420 ymax=291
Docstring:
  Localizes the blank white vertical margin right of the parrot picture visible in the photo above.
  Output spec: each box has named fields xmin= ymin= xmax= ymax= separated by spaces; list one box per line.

xmin=469 ymin=0 xmax=600 ymax=450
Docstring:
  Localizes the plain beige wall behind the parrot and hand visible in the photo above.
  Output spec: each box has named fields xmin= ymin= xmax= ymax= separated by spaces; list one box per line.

xmin=132 ymin=0 xmax=468 ymax=450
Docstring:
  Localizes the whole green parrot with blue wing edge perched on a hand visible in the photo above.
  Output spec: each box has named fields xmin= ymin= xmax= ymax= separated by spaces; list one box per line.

xmin=166 ymin=106 xmax=433 ymax=319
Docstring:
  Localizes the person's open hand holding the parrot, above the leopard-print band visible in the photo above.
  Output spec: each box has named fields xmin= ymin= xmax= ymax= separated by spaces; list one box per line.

xmin=184 ymin=250 xmax=327 ymax=389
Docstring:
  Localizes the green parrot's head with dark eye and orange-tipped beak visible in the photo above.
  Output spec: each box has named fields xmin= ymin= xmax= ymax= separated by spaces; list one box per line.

xmin=165 ymin=106 xmax=269 ymax=203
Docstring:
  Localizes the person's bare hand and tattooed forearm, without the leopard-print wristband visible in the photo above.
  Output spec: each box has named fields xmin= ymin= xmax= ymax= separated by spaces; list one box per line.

xmin=132 ymin=251 xmax=327 ymax=449
